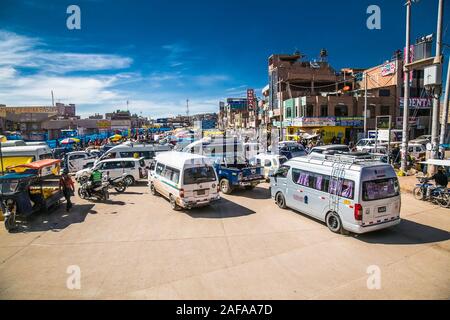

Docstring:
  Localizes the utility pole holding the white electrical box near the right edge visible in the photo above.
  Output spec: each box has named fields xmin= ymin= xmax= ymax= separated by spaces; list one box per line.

xmin=428 ymin=0 xmax=444 ymax=165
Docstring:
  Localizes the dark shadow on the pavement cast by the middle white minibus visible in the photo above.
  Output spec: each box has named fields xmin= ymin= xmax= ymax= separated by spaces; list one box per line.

xmin=184 ymin=198 xmax=256 ymax=219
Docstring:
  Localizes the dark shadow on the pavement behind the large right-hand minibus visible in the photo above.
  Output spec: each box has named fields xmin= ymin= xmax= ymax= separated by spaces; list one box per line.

xmin=355 ymin=219 xmax=450 ymax=245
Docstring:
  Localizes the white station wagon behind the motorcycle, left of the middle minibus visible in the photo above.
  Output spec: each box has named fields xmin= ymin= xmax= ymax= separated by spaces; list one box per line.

xmin=75 ymin=158 xmax=147 ymax=185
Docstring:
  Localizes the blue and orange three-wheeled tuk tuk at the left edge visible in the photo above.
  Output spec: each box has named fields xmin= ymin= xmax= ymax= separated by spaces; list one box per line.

xmin=0 ymin=159 xmax=64 ymax=231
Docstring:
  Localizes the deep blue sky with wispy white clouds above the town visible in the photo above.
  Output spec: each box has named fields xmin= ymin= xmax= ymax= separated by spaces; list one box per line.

xmin=0 ymin=0 xmax=450 ymax=117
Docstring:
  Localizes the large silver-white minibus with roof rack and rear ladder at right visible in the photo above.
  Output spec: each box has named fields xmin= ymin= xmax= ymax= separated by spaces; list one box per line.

xmin=271 ymin=153 xmax=401 ymax=233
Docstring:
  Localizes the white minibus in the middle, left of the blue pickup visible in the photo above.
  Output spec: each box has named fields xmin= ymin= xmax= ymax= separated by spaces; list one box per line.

xmin=148 ymin=151 xmax=220 ymax=210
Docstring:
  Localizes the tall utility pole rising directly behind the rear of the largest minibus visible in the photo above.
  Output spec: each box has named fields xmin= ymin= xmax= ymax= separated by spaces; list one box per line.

xmin=401 ymin=0 xmax=411 ymax=172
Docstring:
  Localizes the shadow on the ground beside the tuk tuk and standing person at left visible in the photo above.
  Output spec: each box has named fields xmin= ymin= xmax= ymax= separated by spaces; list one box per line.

xmin=13 ymin=204 xmax=97 ymax=233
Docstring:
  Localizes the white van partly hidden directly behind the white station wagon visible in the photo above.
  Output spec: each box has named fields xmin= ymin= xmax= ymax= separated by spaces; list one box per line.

xmin=95 ymin=143 xmax=170 ymax=166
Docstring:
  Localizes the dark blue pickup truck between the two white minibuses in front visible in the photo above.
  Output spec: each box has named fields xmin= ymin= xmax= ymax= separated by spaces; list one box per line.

xmin=214 ymin=157 xmax=265 ymax=194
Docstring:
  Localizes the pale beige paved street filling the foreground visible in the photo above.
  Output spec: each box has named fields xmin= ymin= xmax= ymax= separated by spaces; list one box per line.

xmin=0 ymin=184 xmax=450 ymax=299
